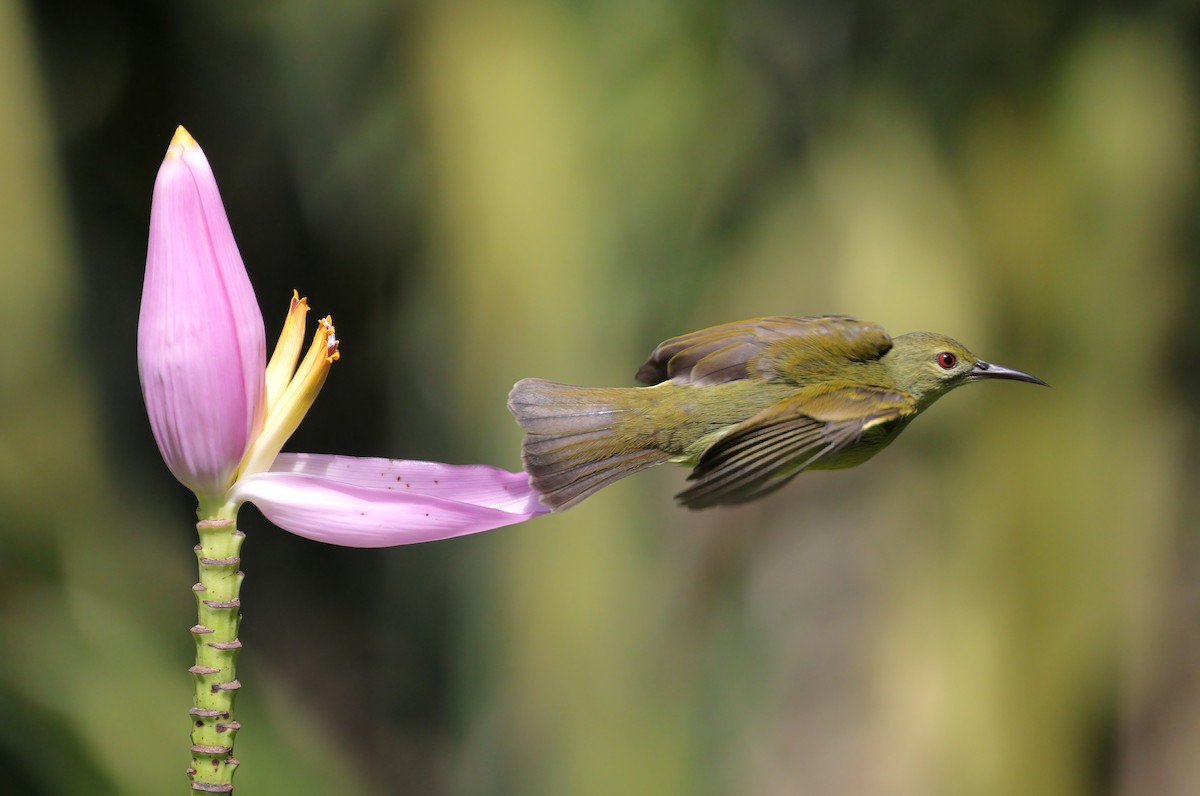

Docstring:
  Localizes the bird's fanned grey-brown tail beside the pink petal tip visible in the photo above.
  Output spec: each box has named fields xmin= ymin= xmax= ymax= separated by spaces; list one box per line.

xmin=509 ymin=378 xmax=670 ymax=510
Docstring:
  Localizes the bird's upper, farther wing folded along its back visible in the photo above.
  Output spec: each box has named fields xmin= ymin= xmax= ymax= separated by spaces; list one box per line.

xmin=637 ymin=315 xmax=892 ymax=384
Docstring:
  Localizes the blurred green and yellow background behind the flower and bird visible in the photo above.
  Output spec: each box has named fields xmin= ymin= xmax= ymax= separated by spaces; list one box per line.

xmin=0 ymin=0 xmax=1200 ymax=796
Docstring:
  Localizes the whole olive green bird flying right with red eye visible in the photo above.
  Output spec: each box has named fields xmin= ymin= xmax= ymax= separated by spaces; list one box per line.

xmin=509 ymin=316 xmax=1045 ymax=510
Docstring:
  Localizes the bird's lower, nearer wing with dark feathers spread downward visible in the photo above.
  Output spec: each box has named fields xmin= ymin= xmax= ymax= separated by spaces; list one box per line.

xmin=676 ymin=383 xmax=917 ymax=509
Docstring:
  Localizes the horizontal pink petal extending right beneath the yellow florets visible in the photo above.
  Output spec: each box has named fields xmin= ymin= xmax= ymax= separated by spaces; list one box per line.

xmin=227 ymin=454 xmax=547 ymax=547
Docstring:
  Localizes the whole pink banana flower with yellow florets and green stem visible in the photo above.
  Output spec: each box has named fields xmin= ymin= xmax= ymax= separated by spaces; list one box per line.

xmin=138 ymin=127 xmax=548 ymax=794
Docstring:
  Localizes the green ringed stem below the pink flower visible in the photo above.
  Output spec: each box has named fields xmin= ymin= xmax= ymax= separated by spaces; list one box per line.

xmin=187 ymin=516 xmax=245 ymax=794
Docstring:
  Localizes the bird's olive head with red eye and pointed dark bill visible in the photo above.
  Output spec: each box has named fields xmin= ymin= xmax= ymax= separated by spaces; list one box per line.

xmin=882 ymin=331 xmax=1045 ymax=408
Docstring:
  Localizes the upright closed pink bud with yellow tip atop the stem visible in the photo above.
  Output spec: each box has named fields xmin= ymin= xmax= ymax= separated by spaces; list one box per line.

xmin=138 ymin=127 xmax=266 ymax=496
